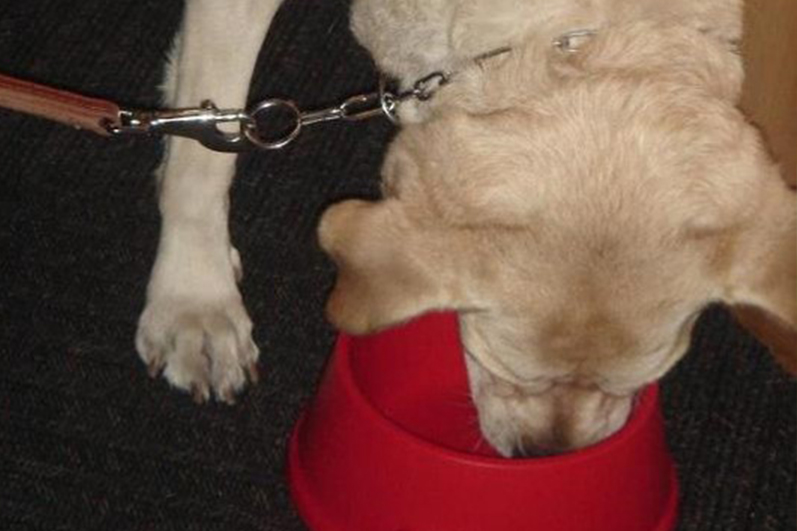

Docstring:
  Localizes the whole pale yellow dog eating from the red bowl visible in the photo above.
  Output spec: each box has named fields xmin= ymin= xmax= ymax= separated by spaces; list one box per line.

xmin=136 ymin=0 xmax=797 ymax=456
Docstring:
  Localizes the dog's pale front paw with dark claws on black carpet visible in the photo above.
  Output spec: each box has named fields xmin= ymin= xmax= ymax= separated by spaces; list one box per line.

xmin=136 ymin=244 xmax=259 ymax=404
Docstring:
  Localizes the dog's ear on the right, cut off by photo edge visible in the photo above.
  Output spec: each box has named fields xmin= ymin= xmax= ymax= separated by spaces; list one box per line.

xmin=726 ymin=181 xmax=797 ymax=374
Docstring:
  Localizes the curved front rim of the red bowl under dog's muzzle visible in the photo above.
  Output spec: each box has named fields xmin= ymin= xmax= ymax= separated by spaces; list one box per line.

xmin=333 ymin=332 xmax=659 ymax=471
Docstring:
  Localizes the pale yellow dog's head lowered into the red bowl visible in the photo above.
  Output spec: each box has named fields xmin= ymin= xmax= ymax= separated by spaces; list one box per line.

xmin=320 ymin=28 xmax=797 ymax=455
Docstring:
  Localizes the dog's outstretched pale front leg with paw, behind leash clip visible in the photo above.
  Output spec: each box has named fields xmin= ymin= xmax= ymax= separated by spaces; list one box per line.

xmin=136 ymin=0 xmax=280 ymax=403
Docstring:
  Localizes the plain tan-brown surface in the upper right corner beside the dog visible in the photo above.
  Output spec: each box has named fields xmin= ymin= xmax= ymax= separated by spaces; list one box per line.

xmin=740 ymin=0 xmax=797 ymax=185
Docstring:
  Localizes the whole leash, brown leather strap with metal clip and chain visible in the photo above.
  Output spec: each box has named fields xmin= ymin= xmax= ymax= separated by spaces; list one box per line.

xmin=0 ymin=33 xmax=595 ymax=153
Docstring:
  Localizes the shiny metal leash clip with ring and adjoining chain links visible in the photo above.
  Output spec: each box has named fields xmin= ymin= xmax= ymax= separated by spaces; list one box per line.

xmin=108 ymin=72 xmax=449 ymax=153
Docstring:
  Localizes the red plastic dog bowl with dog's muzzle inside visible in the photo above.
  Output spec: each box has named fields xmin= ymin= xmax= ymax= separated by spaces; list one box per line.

xmin=288 ymin=314 xmax=678 ymax=531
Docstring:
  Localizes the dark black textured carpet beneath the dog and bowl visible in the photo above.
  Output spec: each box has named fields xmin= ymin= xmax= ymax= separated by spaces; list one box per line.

xmin=0 ymin=0 xmax=797 ymax=531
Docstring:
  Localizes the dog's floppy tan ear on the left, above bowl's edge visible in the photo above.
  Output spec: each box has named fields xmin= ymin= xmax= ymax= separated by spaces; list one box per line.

xmin=319 ymin=199 xmax=478 ymax=334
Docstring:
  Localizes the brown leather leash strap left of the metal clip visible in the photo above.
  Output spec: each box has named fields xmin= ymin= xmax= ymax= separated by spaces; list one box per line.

xmin=0 ymin=74 xmax=120 ymax=136
